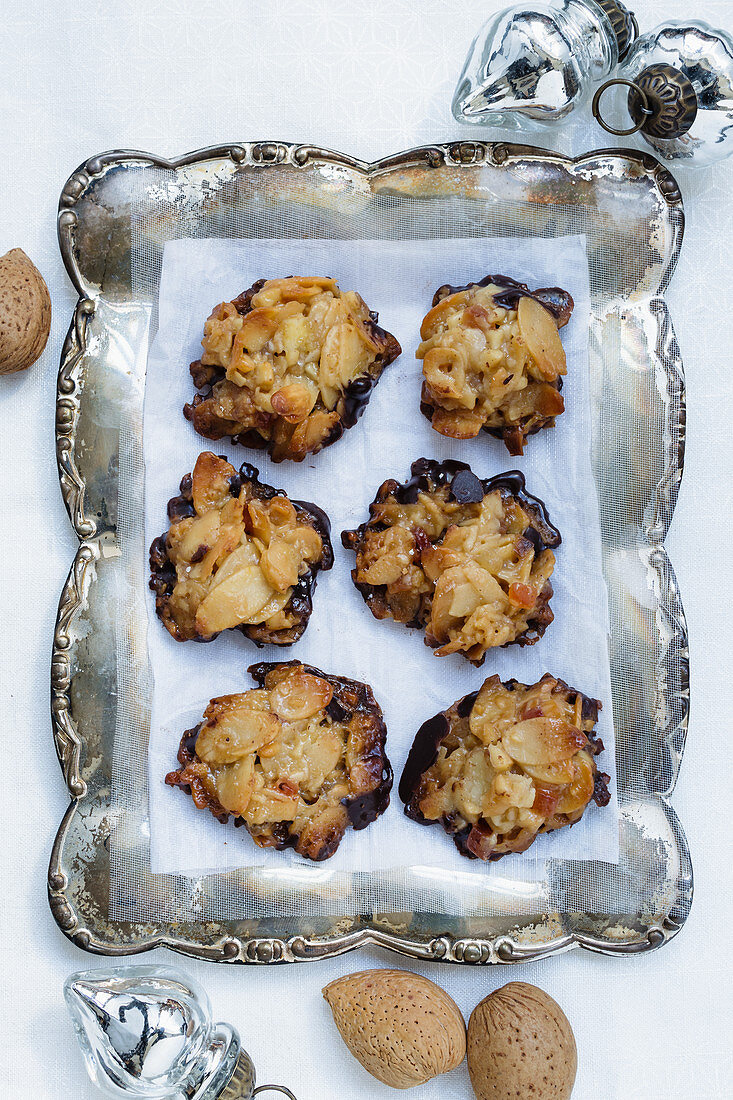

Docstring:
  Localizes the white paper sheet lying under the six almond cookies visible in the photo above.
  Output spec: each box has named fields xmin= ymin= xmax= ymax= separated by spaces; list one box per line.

xmin=144 ymin=237 xmax=619 ymax=877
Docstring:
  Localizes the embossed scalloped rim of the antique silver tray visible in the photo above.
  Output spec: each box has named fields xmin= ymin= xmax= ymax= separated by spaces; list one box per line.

xmin=48 ymin=141 xmax=692 ymax=964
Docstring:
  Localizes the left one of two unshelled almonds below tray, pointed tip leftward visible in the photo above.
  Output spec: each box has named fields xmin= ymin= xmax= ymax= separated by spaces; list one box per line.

xmin=324 ymin=970 xmax=466 ymax=1089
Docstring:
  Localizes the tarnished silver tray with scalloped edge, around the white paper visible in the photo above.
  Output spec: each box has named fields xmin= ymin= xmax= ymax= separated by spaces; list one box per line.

xmin=48 ymin=141 xmax=692 ymax=964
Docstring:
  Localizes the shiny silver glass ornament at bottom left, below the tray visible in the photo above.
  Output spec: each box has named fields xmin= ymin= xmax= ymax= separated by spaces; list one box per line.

xmin=64 ymin=966 xmax=295 ymax=1100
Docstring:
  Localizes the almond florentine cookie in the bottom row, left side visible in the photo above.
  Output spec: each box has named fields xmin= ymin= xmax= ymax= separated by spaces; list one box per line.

xmin=165 ymin=661 xmax=392 ymax=860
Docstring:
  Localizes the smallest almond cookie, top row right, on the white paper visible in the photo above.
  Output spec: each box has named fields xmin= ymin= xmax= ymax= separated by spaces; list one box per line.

xmin=416 ymin=275 xmax=572 ymax=454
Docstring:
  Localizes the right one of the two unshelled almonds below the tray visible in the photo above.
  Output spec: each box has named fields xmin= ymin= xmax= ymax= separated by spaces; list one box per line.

xmin=468 ymin=981 xmax=578 ymax=1100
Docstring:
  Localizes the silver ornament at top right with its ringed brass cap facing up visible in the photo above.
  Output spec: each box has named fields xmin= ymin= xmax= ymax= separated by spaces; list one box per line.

xmin=593 ymin=22 xmax=733 ymax=167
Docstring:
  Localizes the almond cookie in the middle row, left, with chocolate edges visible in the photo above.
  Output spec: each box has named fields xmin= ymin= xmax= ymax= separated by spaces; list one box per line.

xmin=150 ymin=451 xmax=333 ymax=646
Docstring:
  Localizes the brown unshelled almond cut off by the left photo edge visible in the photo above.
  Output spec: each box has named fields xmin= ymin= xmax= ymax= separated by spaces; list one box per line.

xmin=0 ymin=249 xmax=51 ymax=374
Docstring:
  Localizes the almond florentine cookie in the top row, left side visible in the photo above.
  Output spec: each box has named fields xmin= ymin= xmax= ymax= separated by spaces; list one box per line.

xmin=184 ymin=276 xmax=402 ymax=462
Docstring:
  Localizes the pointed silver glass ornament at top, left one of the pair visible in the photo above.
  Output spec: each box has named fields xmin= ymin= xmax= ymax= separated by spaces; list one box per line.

xmin=452 ymin=0 xmax=638 ymax=130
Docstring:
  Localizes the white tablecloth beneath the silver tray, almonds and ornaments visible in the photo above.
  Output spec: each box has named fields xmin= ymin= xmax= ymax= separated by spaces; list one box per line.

xmin=0 ymin=0 xmax=733 ymax=1100
